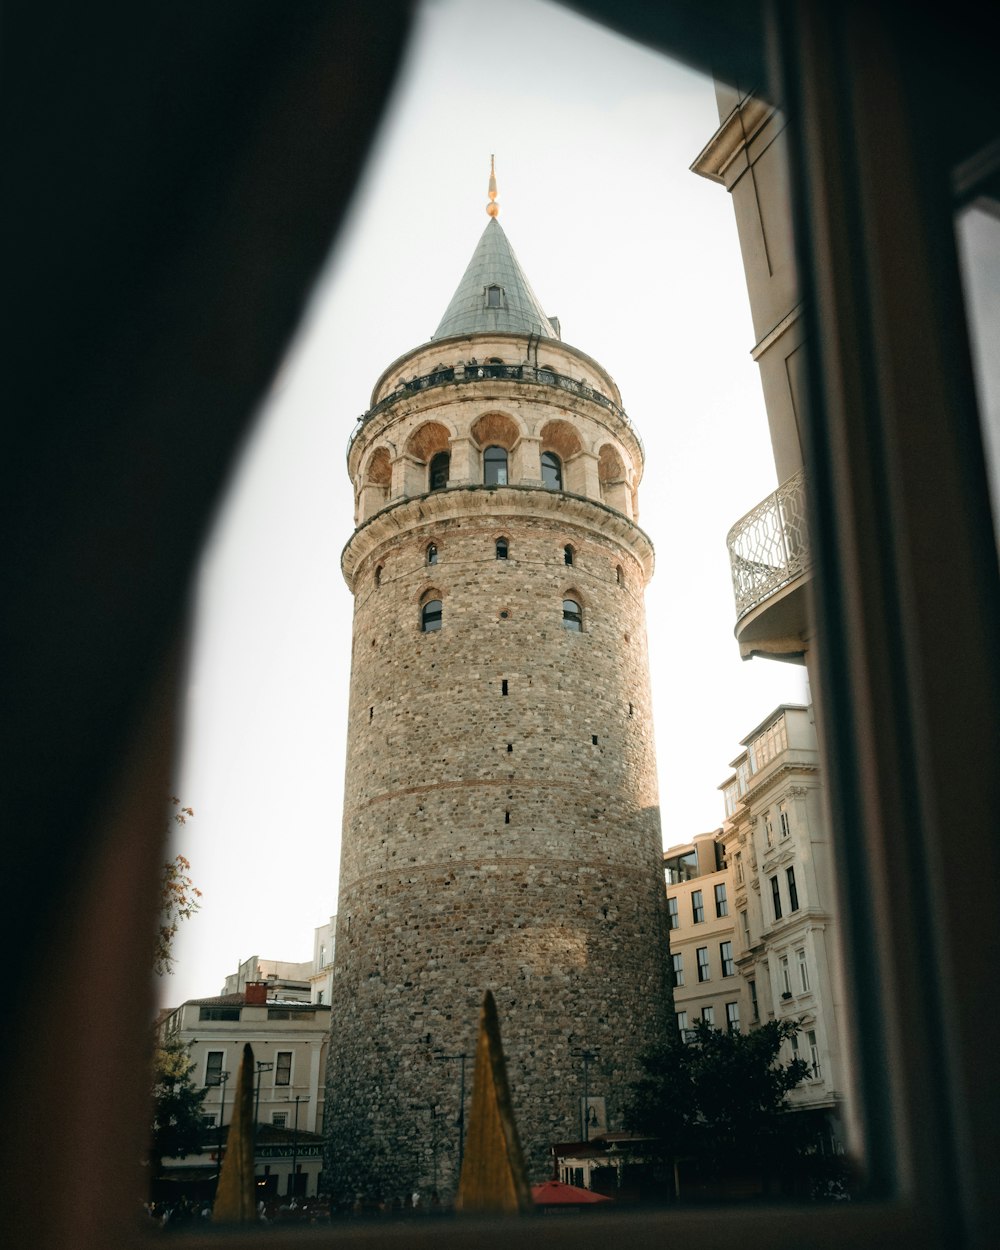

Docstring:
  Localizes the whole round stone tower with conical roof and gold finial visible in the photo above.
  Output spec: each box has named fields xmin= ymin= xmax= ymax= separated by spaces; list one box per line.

xmin=325 ymin=168 xmax=670 ymax=1199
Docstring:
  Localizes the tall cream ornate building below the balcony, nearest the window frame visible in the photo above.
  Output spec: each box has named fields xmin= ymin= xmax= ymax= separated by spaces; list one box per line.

xmin=720 ymin=705 xmax=845 ymax=1134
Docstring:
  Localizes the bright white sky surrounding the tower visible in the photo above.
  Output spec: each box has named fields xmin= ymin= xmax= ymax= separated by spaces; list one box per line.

xmin=161 ymin=0 xmax=806 ymax=1005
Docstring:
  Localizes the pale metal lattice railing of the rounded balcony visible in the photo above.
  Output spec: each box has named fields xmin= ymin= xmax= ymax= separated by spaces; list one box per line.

xmin=726 ymin=469 xmax=813 ymax=621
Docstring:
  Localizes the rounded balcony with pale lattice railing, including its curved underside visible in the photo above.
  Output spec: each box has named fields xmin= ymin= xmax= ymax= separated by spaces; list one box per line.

xmin=726 ymin=469 xmax=813 ymax=663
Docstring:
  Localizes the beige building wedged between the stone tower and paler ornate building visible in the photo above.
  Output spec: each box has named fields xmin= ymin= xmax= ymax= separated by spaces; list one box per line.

xmin=664 ymin=830 xmax=749 ymax=1034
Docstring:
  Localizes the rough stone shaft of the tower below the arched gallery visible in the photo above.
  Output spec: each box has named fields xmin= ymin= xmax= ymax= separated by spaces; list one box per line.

xmin=325 ymin=357 xmax=673 ymax=1200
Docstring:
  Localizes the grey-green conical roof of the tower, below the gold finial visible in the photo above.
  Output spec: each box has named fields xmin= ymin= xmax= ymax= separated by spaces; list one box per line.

xmin=431 ymin=216 xmax=559 ymax=339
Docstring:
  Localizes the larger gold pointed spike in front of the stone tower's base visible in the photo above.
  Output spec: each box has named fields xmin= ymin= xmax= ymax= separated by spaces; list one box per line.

xmin=455 ymin=990 xmax=534 ymax=1215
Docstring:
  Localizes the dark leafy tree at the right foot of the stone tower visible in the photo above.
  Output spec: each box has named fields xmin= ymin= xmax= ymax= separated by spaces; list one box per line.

xmin=625 ymin=1020 xmax=819 ymax=1189
